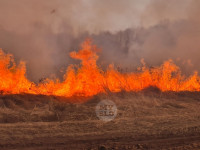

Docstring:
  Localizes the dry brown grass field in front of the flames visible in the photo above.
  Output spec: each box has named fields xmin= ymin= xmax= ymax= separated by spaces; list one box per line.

xmin=0 ymin=88 xmax=200 ymax=150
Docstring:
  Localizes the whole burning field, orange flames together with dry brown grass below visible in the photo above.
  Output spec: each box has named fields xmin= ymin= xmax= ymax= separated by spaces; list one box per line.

xmin=0 ymin=39 xmax=200 ymax=149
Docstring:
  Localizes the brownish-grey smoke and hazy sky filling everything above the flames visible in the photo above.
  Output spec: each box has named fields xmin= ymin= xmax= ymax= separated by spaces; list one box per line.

xmin=0 ymin=0 xmax=200 ymax=81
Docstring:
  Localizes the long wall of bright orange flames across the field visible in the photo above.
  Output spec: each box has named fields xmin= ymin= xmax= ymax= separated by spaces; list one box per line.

xmin=0 ymin=39 xmax=200 ymax=97
